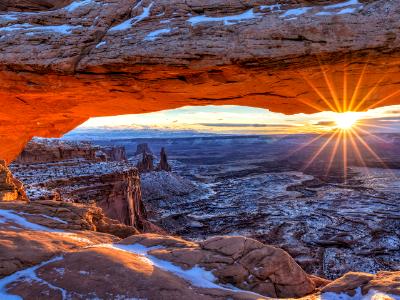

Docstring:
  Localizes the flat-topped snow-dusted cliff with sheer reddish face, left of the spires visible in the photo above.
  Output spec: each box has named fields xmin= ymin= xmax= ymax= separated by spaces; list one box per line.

xmin=11 ymin=140 xmax=152 ymax=231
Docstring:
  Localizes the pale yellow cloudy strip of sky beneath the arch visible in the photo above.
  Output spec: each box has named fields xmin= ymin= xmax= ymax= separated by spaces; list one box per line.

xmin=73 ymin=105 xmax=400 ymax=134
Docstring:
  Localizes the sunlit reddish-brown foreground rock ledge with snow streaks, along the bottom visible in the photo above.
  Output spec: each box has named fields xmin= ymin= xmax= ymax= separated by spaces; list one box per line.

xmin=0 ymin=201 xmax=400 ymax=300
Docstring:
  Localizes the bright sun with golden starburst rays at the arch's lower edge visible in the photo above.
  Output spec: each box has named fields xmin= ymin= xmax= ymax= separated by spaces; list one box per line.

xmin=291 ymin=58 xmax=394 ymax=183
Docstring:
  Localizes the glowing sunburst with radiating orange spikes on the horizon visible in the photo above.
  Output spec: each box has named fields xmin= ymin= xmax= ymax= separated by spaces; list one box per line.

xmin=295 ymin=57 xmax=400 ymax=182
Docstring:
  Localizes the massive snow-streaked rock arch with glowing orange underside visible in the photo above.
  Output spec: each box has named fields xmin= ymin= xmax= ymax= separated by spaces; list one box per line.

xmin=0 ymin=0 xmax=400 ymax=162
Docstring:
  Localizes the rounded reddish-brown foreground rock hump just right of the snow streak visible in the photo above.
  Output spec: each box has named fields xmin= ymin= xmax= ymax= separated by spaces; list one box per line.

xmin=121 ymin=235 xmax=315 ymax=298
